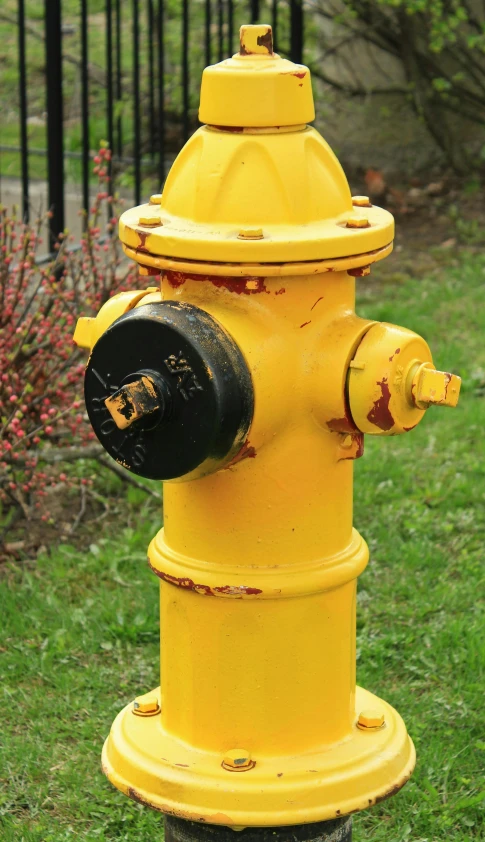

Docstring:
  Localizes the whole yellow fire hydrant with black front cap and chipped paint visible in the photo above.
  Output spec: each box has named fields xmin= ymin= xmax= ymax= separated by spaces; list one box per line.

xmin=75 ymin=26 xmax=460 ymax=842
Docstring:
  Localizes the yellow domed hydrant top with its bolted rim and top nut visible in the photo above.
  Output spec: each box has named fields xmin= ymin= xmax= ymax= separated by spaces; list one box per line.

xmin=119 ymin=25 xmax=394 ymax=268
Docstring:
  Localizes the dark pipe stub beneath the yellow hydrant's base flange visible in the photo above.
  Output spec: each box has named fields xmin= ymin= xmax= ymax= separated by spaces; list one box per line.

xmin=165 ymin=816 xmax=352 ymax=842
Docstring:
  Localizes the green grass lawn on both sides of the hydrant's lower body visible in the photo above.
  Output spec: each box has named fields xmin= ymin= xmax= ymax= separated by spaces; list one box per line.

xmin=0 ymin=246 xmax=485 ymax=842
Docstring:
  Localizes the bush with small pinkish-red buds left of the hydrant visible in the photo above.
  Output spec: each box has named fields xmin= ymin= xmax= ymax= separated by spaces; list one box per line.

xmin=0 ymin=147 xmax=139 ymax=530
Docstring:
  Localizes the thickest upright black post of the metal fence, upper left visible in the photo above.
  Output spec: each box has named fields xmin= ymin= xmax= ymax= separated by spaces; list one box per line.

xmin=44 ymin=0 xmax=64 ymax=250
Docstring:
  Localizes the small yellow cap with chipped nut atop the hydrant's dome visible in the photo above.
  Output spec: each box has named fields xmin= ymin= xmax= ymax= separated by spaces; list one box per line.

xmin=199 ymin=24 xmax=315 ymax=129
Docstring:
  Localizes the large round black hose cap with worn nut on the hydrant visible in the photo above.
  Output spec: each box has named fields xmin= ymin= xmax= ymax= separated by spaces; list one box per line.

xmin=84 ymin=301 xmax=254 ymax=480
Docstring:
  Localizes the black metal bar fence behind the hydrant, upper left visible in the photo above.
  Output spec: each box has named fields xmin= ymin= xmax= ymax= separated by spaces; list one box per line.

xmin=0 ymin=0 xmax=304 ymax=249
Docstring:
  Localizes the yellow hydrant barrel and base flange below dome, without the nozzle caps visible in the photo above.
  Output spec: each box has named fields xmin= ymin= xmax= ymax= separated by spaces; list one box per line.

xmin=99 ymin=271 xmax=414 ymax=826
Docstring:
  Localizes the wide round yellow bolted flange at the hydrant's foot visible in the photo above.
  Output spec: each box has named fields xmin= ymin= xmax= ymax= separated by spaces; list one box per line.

xmin=102 ymin=687 xmax=416 ymax=827
